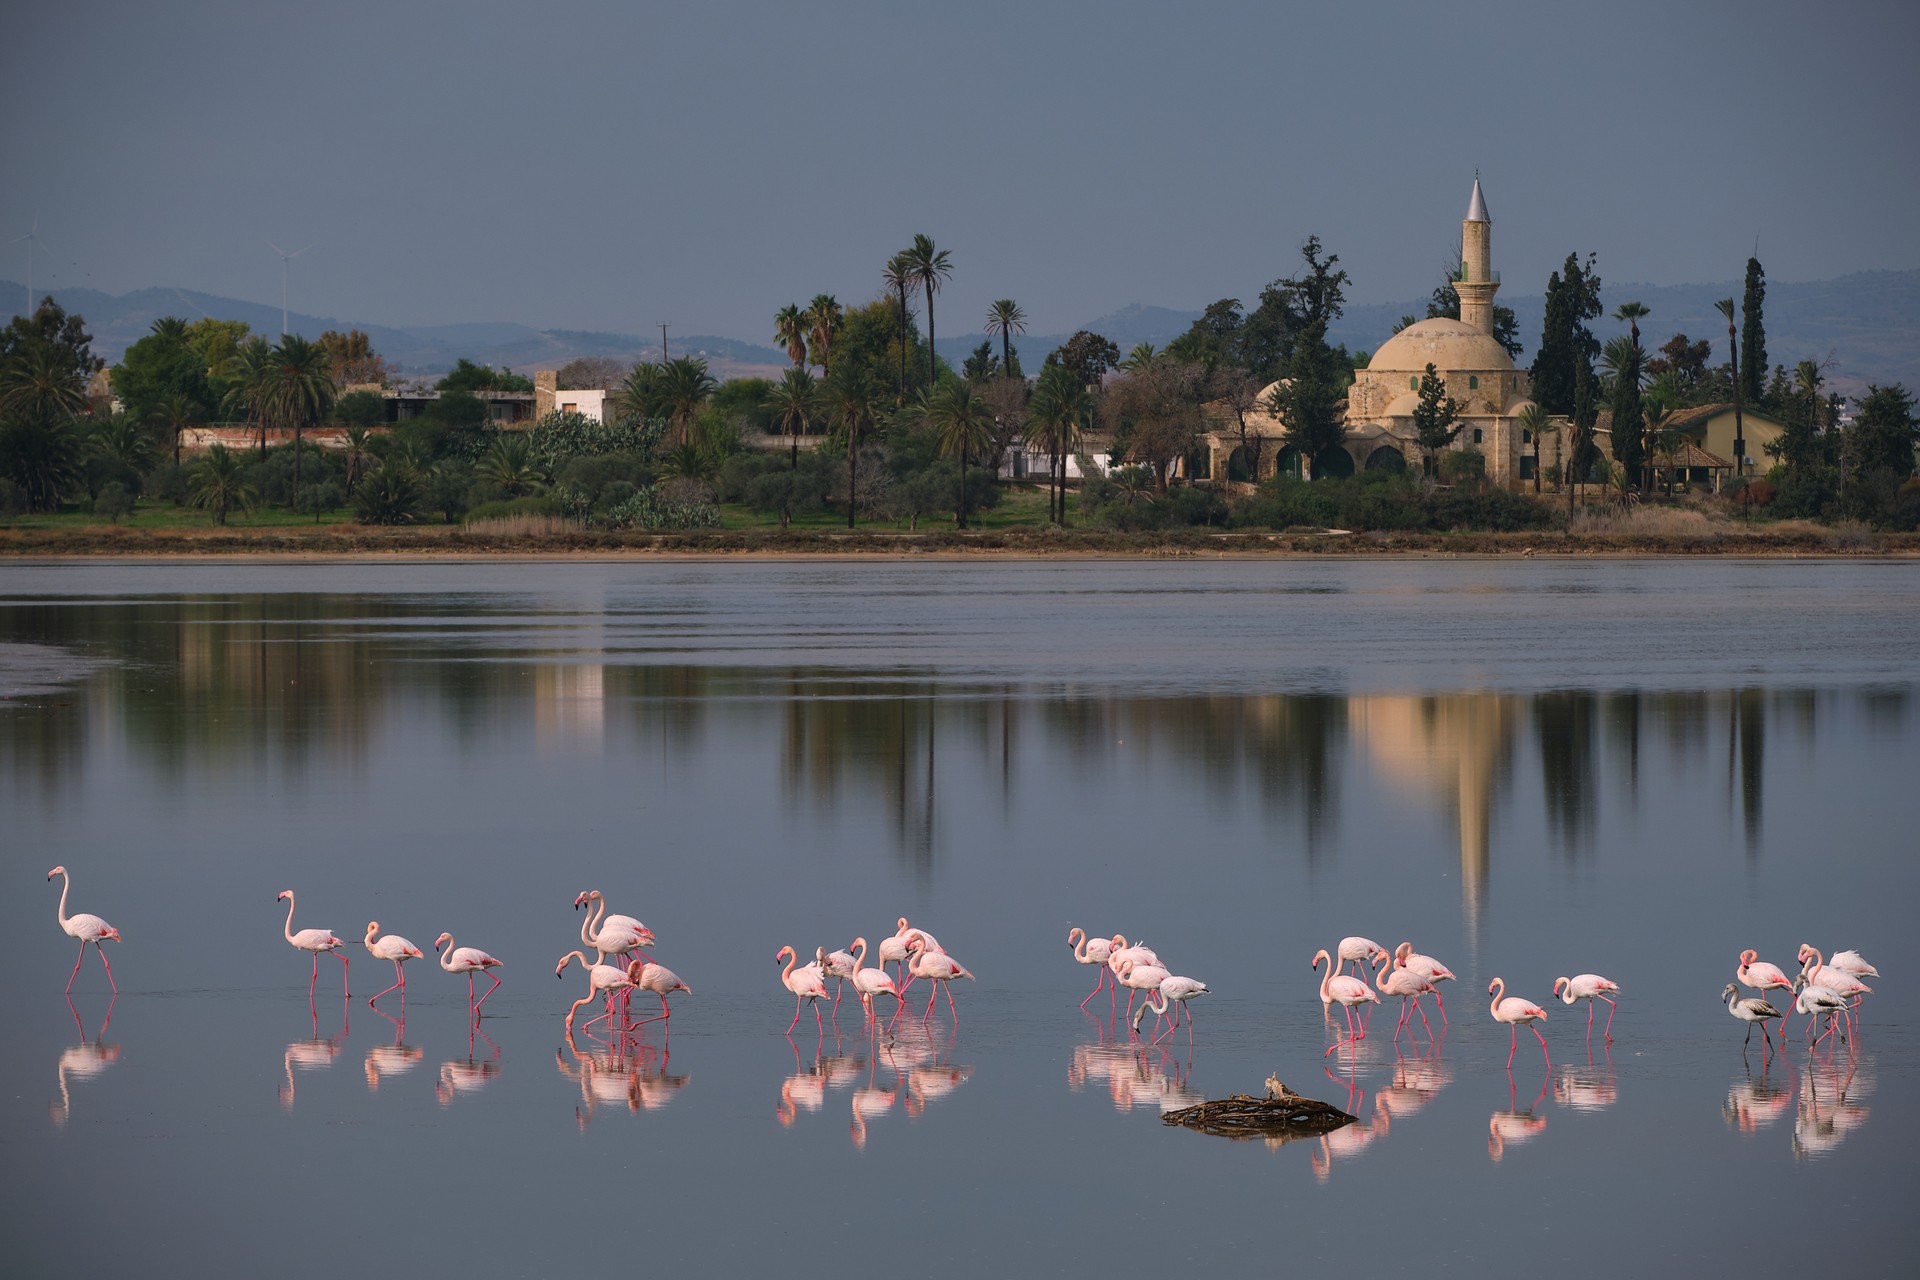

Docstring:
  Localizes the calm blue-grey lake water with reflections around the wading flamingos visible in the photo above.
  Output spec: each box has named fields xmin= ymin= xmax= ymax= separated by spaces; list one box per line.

xmin=0 ymin=560 xmax=1920 ymax=1276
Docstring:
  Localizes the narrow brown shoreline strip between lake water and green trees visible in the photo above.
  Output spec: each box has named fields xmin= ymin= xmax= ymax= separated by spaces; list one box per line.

xmin=0 ymin=526 xmax=1920 ymax=564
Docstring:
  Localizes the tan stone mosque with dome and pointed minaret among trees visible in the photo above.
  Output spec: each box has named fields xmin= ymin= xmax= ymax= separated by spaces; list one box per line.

xmin=1204 ymin=177 xmax=1534 ymax=487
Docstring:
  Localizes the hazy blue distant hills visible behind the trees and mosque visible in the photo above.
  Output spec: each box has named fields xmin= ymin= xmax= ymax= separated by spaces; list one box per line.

xmin=0 ymin=271 xmax=1920 ymax=391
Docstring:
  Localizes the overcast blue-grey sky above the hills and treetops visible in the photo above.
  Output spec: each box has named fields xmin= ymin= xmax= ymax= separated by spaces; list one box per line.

xmin=0 ymin=0 xmax=1920 ymax=342
